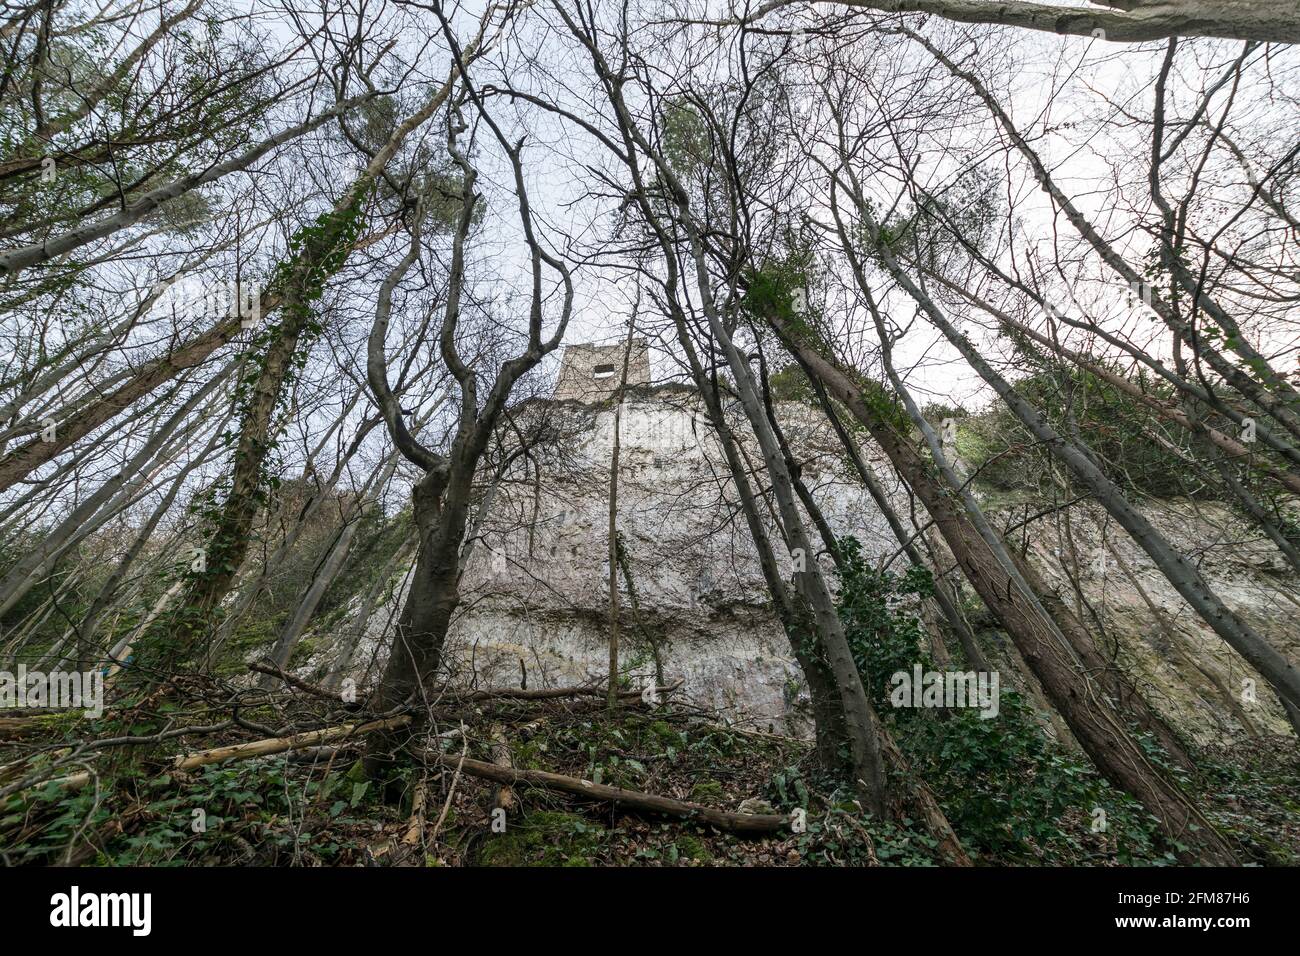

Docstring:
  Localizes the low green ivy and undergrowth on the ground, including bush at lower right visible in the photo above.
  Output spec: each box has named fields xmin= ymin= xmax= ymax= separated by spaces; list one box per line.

xmin=0 ymin=702 xmax=1300 ymax=866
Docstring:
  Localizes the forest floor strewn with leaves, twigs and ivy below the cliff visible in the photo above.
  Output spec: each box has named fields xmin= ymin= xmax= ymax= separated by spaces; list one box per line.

xmin=0 ymin=681 xmax=1300 ymax=866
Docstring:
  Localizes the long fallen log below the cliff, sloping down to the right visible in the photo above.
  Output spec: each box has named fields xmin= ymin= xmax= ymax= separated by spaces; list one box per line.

xmin=428 ymin=753 xmax=790 ymax=834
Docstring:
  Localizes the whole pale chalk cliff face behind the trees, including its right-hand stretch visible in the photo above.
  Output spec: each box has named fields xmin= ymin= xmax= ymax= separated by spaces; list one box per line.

xmin=322 ymin=388 xmax=1300 ymax=739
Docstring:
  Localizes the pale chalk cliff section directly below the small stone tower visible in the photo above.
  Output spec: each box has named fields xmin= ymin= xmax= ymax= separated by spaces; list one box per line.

xmin=441 ymin=390 xmax=888 ymax=731
